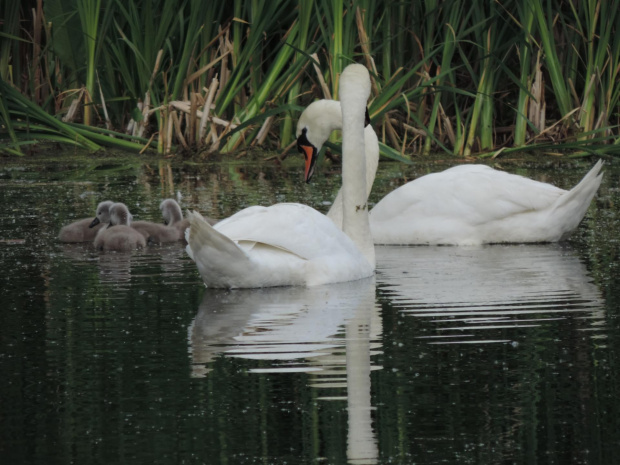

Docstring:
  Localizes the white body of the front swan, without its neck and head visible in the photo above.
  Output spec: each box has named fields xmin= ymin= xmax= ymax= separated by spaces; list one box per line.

xmin=187 ymin=203 xmax=373 ymax=288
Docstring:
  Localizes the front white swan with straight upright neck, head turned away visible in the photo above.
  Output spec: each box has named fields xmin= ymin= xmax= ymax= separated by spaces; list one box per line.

xmin=186 ymin=65 xmax=375 ymax=288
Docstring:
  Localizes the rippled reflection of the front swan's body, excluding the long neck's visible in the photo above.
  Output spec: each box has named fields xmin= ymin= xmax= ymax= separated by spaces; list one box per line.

xmin=189 ymin=279 xmax=381 ymax=376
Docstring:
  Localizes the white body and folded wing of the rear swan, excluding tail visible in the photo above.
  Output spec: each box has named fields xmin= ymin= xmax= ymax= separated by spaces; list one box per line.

xmin=370 ymin=165 xmax=566 ymax=245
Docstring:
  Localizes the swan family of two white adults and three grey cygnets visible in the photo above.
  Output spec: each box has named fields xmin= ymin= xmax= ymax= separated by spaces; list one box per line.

xmin=59 ymin=64 xmax=603 ymax=288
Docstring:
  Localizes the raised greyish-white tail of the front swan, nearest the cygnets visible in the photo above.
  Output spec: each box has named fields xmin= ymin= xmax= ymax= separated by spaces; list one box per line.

xmin=185 ymin=211 xmax=250 ymax=287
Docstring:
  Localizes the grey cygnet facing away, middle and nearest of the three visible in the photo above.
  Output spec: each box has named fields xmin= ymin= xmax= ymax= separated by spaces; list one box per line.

xmin=95 ymin=203 xmax=146 ymax=251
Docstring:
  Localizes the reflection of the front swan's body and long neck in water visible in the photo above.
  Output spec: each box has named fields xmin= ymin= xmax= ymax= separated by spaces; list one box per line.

xmin=189 ymin=278 xmax=382 ymax=464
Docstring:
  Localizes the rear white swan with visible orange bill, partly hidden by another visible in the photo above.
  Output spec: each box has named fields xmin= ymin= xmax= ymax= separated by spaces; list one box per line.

xmin=297 ymin=100 xmax=603 ymax=245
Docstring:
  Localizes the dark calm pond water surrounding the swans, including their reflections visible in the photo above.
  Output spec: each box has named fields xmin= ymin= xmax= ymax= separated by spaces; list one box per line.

xmin=0 ymin=151 xmax=620 ymax=465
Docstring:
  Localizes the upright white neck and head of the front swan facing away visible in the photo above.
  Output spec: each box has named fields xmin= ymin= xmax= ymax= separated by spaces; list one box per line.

xmin=339 ymin=65 xmax=375 ymax=266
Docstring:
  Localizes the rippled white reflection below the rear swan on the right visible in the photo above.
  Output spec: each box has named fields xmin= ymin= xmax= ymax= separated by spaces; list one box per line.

xmin=377 ymin=244 xmax=605 ymax=344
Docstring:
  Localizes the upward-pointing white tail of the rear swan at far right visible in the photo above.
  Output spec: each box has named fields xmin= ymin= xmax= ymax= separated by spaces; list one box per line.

xmin=551 ymin=160 xmax=603 ymax=240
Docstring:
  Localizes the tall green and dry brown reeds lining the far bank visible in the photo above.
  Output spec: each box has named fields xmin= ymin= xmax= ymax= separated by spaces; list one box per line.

xmin=0 ymin=0 xmax=620 ymax=160
